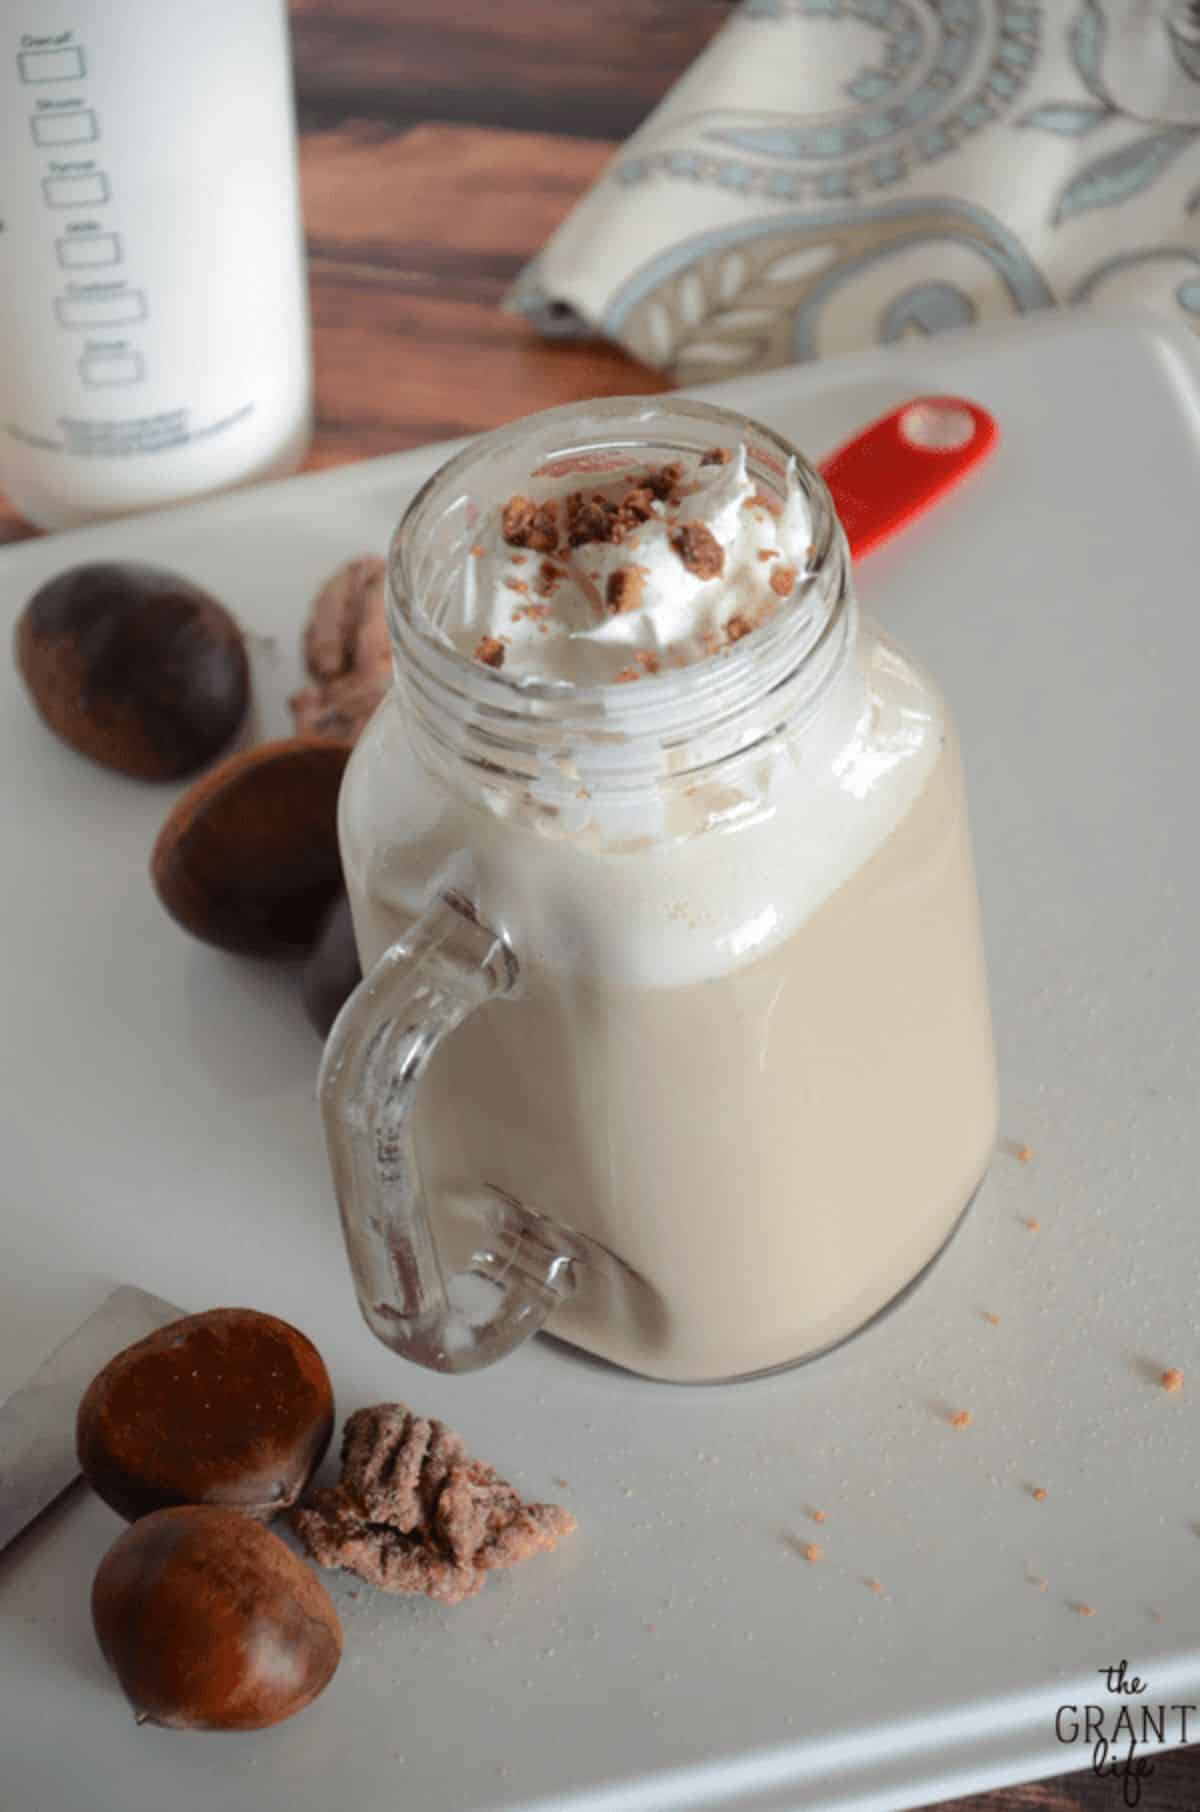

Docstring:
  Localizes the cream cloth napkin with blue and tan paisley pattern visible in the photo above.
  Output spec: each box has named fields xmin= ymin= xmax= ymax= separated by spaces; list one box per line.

xmin=508 ymin=0 xmax=1200 ymax=384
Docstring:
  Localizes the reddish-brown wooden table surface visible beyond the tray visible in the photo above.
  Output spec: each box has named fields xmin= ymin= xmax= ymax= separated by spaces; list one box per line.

xmin=0 ymin=0 xmax=1200 ymax=1812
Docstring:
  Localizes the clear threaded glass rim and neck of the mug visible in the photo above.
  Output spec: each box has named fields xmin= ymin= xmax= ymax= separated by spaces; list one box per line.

xmin=388 ymin=395 xmax=857 ymax=823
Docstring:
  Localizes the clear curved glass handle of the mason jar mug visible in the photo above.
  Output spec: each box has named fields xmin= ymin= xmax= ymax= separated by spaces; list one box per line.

xmin=317 ymin=890 xmax=589 ymax=1372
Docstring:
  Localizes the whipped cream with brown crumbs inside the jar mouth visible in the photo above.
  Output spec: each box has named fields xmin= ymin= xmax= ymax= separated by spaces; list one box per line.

xmin=437 ymin=446 xmax=812 ymax=687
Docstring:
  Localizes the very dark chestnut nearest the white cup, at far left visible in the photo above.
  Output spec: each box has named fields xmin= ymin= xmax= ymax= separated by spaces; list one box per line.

xmin=16 ymin=560 xmax=250 ymax=781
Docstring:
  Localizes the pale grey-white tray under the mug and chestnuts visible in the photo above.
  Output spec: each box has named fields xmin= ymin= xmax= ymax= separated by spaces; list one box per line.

xmin=0 ymin=315 xmax=1200 ymax=1812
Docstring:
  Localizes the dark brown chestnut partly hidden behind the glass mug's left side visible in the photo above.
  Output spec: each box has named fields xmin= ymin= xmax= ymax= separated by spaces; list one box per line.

xmin=150 ymin=737 xmax=350 ymax=957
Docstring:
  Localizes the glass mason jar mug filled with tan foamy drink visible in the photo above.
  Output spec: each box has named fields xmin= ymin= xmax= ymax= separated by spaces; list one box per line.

xmin=321 ymin=400 xmax=997 ymax=1381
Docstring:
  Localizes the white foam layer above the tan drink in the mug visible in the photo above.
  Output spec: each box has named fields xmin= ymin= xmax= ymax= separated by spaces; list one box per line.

xmin=341 ymin=625 xmax=946 ymax=988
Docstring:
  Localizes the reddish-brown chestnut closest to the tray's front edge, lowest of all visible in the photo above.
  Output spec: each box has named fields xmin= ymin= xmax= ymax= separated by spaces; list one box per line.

xmin=92 ymin=1504 xmax=343 ymax=1730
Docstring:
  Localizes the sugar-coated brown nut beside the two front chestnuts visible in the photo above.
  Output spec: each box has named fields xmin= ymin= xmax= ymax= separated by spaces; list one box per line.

xmin=292 ymin=1402 xmax=576 ymax=1604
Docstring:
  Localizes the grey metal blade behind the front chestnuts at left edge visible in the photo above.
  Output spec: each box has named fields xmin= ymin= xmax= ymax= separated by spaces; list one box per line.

xmin=0 ymin=1283 xmax=183 ymax=1549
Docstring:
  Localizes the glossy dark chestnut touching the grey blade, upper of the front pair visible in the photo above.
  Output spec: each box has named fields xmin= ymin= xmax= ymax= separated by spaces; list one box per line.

xmin=76 ymin=1308 xmax=334 ymax=1522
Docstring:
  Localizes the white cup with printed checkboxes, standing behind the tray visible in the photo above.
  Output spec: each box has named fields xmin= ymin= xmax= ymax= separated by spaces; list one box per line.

xmin=0 ymin=0 xmax=312 ymax=529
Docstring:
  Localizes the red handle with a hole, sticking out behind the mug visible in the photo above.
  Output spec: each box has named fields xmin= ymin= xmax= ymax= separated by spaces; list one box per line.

xmin=821 ymin=397 xmax=997 ymax=560
